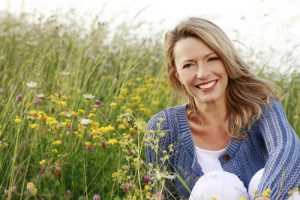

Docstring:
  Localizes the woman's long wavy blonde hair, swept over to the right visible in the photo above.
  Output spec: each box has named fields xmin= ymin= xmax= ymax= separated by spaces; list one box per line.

xmin=165 ymin=17 xmax=279 ymax=139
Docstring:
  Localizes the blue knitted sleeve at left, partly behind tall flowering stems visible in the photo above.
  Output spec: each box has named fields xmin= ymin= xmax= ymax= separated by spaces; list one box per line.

xmin=145 ymin=111 xmax=176 ymax=199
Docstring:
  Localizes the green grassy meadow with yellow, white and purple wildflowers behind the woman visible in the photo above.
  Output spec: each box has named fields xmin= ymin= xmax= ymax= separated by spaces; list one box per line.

xmin=0 ymin=13 xmax=300 ymax=200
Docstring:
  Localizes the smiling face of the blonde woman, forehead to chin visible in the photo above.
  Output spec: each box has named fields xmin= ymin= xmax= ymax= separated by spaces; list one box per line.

xmin=174 ymin=37 xmax=228 ymax=103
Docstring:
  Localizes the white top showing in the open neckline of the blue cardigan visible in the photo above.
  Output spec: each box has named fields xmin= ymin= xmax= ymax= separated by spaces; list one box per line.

xmin=195 ymin=146 xmax=226 ymax=174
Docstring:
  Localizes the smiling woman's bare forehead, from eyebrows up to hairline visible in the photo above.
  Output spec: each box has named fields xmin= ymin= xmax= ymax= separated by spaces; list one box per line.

xmin=174 ymin=37 xmax=214 ymax=60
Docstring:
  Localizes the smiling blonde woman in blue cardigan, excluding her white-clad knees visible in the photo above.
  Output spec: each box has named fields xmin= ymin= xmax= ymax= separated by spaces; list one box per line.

xmin=146 ymin=18 xmax=300 ymax=200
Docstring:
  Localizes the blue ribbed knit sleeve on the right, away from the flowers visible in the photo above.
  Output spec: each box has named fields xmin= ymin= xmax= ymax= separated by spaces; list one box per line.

xmin=258 ymin=100 xmax=300 ymax=200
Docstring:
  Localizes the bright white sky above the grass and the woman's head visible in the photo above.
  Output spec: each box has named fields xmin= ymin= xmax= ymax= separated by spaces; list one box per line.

xmin=0 ymin=0 xmax=300 ymax=71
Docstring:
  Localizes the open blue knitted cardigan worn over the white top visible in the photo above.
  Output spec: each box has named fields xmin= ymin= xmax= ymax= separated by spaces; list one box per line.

xmin=146 ymin=100 xmax=300 ymax=200
